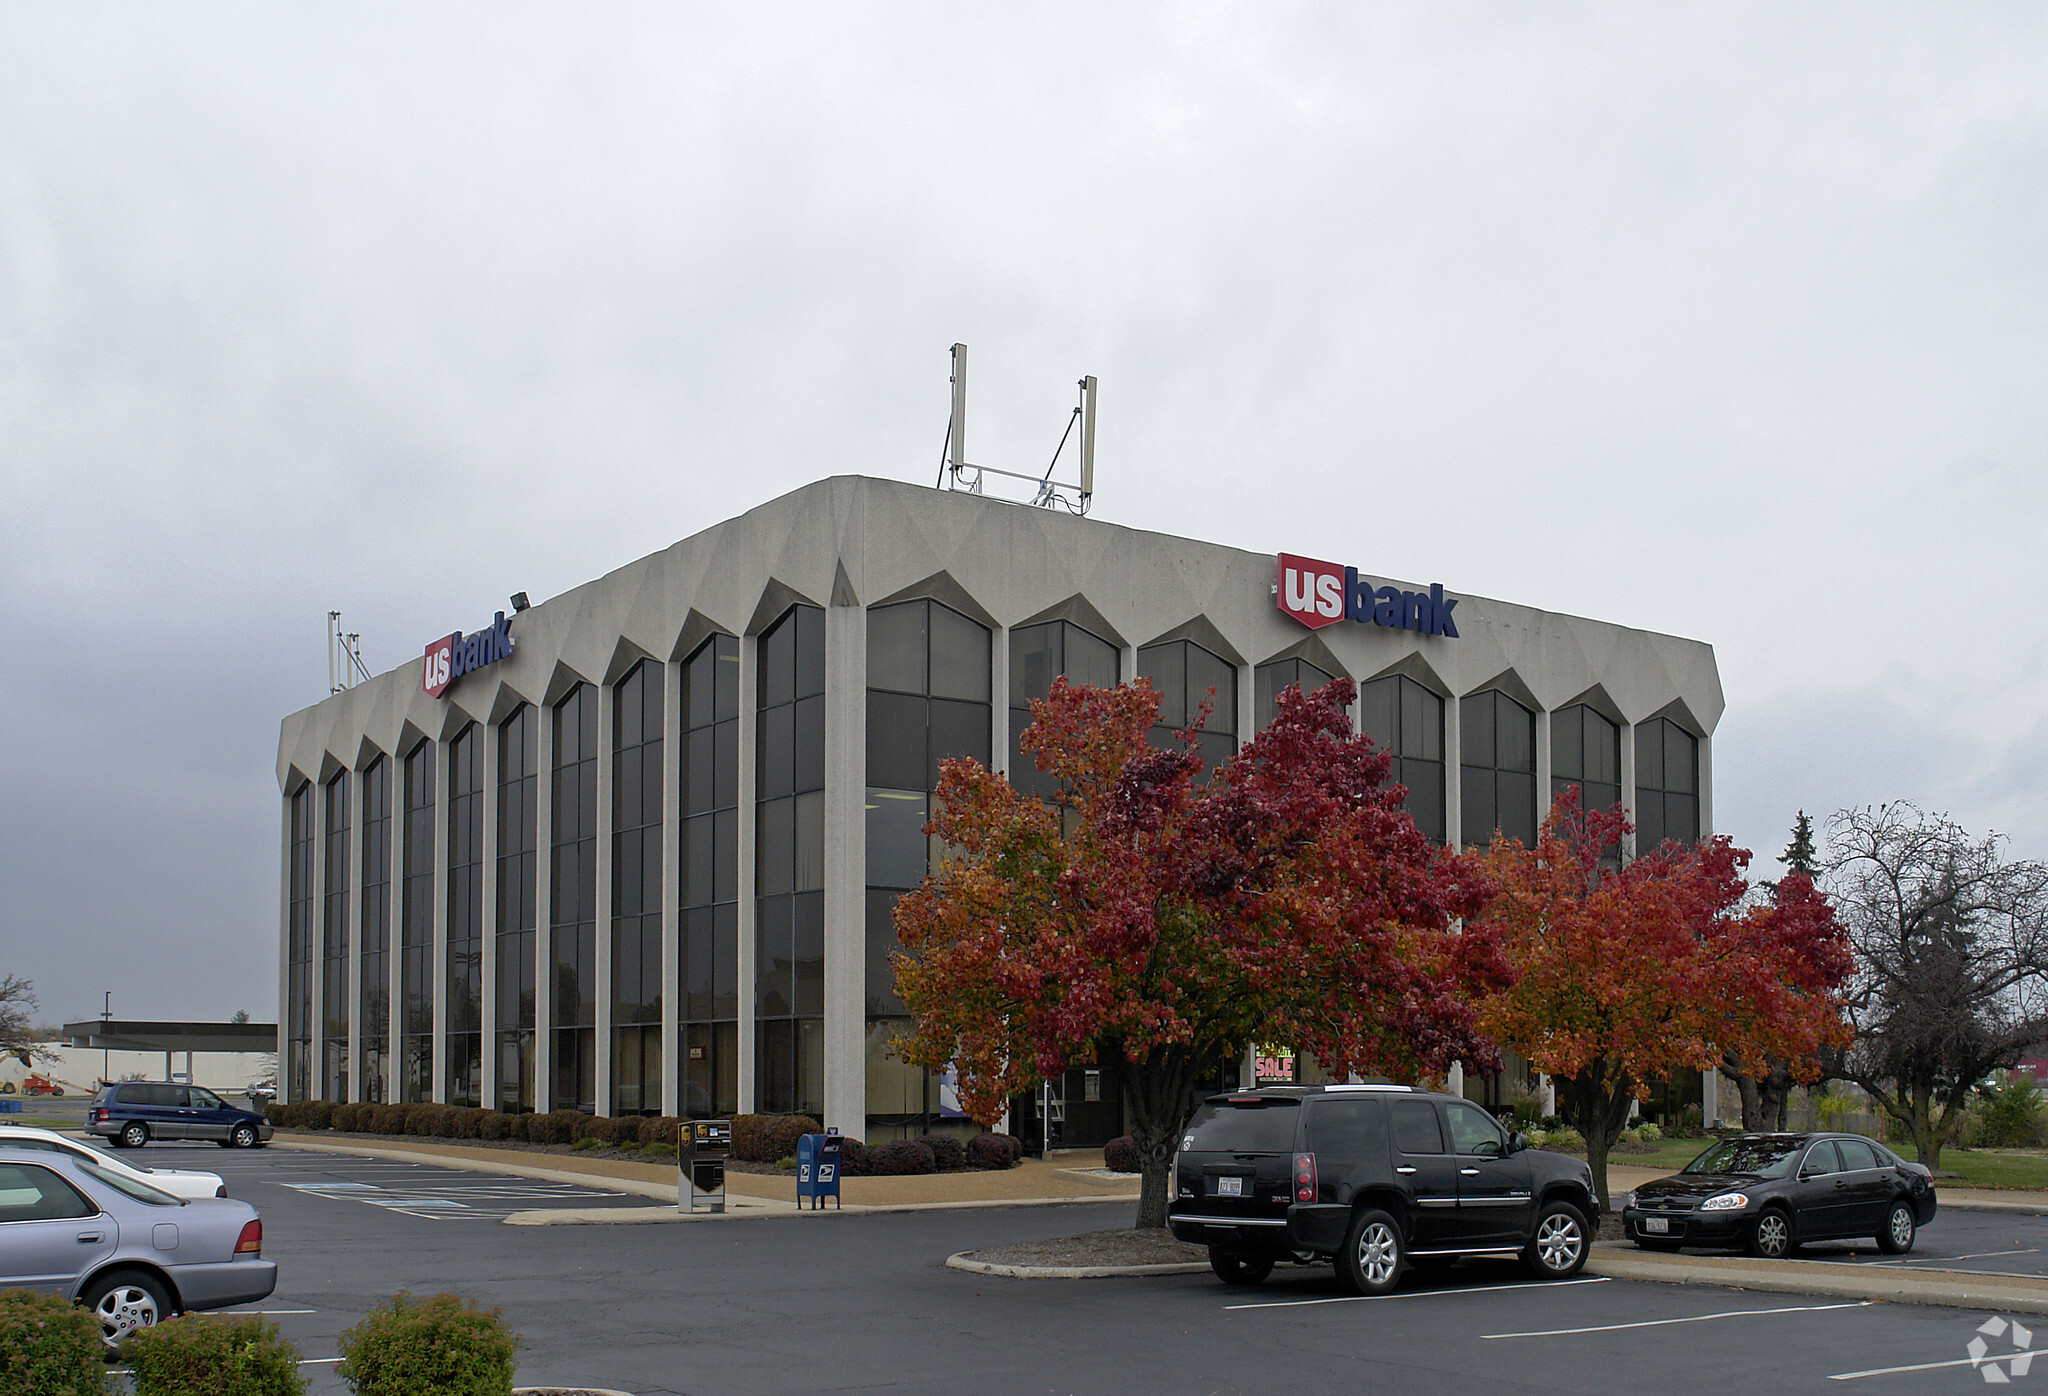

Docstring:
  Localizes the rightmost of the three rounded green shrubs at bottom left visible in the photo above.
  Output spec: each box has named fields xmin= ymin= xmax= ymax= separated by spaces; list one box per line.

xmin=340 ymin=1294 xmax=518 ymax=1396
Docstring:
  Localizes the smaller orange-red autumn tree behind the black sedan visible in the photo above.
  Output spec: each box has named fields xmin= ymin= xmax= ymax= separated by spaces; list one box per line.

xmin=1470 ymin=794 xmax=1849 ymax=1208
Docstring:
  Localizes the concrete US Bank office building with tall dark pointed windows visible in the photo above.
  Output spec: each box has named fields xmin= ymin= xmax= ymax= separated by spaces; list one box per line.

xmin=276 ymin=477 xmax=1722 ymax=1140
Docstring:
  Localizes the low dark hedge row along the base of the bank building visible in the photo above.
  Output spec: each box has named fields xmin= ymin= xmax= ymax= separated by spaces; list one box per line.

xmin=270 ymin=1101 xmax=1024 ymax=1177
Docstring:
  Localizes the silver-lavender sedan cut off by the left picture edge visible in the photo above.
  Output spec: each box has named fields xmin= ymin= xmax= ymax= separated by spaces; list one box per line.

xmin=0 ymin=1148 xmax=276 ymax=1349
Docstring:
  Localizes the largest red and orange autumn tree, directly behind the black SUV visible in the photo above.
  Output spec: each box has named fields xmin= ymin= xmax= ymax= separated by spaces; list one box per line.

xmin=895 ymin=680 xmax=1503 ymax=1226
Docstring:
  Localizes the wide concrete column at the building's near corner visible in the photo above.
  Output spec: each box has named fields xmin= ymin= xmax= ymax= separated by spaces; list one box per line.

xmin=825 ymin=606 xmax=868 ymax=1138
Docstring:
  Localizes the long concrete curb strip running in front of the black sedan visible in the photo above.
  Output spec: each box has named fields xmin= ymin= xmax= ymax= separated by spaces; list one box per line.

xmin=1585 ymin=1242 xmax=2048 ymax=1314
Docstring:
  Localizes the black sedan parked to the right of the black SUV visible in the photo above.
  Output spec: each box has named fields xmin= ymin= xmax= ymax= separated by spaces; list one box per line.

xmin=1622 ymin=1134 xmax=1935 ymax=1259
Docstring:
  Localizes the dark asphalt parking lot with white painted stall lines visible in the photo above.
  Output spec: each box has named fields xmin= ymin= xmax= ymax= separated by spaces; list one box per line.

xmin=68 ymin=1144 xmax=2048 ymax=1396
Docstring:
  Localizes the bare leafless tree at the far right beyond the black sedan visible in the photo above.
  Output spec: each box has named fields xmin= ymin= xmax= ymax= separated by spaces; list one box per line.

xmin=1825 ymin=802 xmax=2048 ymax=1169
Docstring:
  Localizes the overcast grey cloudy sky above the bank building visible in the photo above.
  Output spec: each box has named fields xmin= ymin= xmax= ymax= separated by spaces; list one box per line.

xmin=0 ymin=2 xmax=2048 ymax=1019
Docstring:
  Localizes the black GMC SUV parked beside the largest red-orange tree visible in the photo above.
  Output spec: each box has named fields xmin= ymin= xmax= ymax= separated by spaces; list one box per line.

xmin=1167 ymin=1085 xmax=1599 ymax=1294
